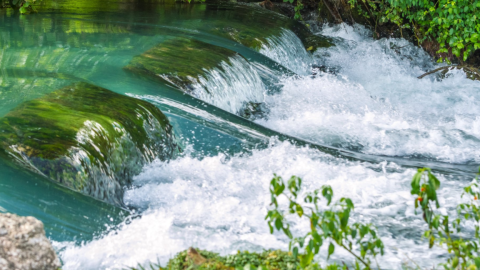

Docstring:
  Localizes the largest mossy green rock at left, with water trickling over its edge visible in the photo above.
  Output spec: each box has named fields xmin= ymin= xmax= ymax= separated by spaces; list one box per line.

xmin=0 ymin=83 xmax=179 ymax=205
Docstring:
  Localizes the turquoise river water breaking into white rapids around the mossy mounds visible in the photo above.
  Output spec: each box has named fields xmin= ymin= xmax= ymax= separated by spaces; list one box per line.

xmin=0 ymin=1 xmax=480 ymax=269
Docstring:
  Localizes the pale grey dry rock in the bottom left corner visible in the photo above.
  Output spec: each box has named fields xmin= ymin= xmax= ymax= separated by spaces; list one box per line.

xmin=0 ymin=213 xmax=61 ymax=270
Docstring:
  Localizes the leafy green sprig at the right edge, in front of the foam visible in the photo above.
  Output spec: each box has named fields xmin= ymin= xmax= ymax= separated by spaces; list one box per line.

xmin=411 ymin=168 xmax=480 ymax=270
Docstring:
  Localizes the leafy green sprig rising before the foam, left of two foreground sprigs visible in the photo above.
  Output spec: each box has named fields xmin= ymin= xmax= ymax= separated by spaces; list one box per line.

xmin=266 ymin=175 xmax=384 ymax=269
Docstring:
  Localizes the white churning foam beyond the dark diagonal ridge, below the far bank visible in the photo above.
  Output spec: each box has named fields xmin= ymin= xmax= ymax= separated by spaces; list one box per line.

xmin=258 ymin=25 xmax=480 ymax=163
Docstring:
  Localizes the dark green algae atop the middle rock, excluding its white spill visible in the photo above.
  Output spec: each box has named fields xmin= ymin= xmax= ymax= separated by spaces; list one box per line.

xmin=124 ymin=37 xmax=237 ymax=92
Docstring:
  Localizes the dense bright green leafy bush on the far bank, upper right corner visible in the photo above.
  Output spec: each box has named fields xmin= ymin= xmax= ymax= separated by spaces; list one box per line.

xmin=349 ymin=0 xmax=480 ymax=62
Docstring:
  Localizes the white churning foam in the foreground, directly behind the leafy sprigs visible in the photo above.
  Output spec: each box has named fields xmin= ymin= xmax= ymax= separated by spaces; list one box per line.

xmin=56 ymin=143 xmax=468 ymax=269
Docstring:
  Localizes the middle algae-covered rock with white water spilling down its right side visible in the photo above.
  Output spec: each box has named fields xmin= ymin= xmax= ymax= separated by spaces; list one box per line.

xmin=124 ymin=37 xmax=265 ymax=113
